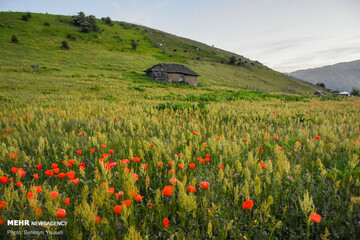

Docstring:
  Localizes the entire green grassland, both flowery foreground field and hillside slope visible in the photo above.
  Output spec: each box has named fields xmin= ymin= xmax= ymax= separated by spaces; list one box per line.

xmin=0 ymin=12 xmax=360 ymax=240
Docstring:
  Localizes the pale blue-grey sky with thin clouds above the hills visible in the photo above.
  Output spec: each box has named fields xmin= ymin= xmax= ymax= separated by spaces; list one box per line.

xmin=0 ymin=0 xmax=360 ymax=72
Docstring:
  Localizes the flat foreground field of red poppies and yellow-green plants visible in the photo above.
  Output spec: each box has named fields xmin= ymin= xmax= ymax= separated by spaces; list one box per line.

xmin=0 ymin=97 xmax=360 ymax=239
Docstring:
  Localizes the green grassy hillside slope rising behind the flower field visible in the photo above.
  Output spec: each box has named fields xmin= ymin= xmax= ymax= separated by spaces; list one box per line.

xmin=0 ymin=12 xmax=316 ymax=105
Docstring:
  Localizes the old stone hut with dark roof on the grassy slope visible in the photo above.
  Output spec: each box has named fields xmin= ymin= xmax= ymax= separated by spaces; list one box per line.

xmin=145 ymin=63 xmax=200 ymax=86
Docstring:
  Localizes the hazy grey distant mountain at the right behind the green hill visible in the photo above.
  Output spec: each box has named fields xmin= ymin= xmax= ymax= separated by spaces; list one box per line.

xmin=288 ymin=60 xmax=360 ymax=91
